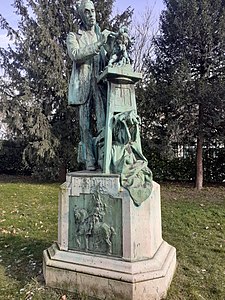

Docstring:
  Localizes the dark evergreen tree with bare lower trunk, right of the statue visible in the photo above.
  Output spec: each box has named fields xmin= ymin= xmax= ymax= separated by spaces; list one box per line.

xmin=149 ymin=0 xmax=225 ymax=189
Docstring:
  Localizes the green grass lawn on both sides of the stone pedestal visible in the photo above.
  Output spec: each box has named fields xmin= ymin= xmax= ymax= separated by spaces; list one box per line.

xmin=0 ymin=176 xmax=225 ymax=300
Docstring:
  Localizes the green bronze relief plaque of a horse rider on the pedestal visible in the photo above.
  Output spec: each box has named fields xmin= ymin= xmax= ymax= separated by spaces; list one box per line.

xmin=69 ymin=190 xmax=122 ymax=257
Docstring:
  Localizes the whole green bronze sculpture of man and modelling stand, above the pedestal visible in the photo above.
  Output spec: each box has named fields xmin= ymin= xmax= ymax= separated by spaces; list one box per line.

xmin=67 ymin=0 xmax=152 ymax=205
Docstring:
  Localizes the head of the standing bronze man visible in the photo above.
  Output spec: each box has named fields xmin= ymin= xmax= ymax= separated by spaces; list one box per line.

xmin=77 ymin=0 xmax=96 ymax=29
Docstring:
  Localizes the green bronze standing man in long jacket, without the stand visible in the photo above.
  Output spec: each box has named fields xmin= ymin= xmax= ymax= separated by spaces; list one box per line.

xmin=67 ymin=0 xmax=106 ymax=171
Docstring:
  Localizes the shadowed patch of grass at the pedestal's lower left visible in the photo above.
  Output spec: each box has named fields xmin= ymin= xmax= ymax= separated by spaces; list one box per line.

xmin=0 ymin=235 xmax=100 ymax=300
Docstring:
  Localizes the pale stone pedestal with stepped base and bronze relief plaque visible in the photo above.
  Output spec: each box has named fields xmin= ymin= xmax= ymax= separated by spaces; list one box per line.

xmin=44 ymin=172 xmax=176 ymax=300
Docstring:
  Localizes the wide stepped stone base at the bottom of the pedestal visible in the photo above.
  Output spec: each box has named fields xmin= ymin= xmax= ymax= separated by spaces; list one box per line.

xmin=44 ymin=242 xmax=176 ymax=300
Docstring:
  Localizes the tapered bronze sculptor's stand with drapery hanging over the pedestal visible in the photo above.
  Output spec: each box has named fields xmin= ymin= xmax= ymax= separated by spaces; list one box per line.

xmin=99 ymin=65 xmax=152 ymax=205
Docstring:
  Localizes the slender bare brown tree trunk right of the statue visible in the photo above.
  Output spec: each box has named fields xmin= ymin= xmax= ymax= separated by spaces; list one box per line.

xmin=195 ymin=135 xmax=203 ymax=190
